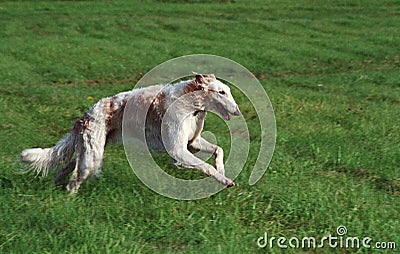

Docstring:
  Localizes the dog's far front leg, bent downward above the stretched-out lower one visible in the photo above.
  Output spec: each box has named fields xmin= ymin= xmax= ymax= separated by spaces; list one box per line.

xmin=190 ymin=136 xmax=225 ymax=175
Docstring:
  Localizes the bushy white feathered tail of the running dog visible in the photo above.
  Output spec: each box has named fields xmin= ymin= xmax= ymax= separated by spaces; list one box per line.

xmin=20 ymin=131 xmax=76 ymax=176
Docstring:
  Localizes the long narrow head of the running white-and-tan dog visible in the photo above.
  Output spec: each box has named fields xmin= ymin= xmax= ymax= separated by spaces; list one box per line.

xmin=194 ymin=73 xmax=240 ymax=121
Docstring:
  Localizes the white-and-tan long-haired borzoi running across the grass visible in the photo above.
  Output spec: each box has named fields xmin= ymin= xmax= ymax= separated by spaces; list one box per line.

xmin=20 ymin=73 xmax=240 ymax=193
